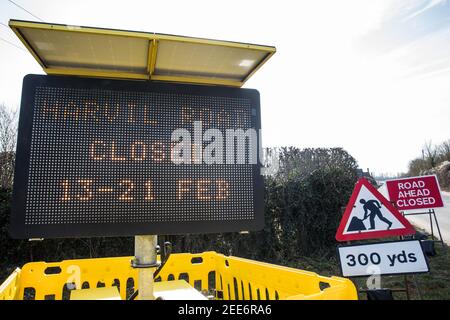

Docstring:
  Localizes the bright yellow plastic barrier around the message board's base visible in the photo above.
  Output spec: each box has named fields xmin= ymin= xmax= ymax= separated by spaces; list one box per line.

xmin=0 ymin=252 xmax=357 ymax=300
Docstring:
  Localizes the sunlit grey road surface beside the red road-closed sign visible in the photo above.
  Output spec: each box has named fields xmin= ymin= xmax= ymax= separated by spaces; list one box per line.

xmin=407 ymin=191 xmax=450 ymax=245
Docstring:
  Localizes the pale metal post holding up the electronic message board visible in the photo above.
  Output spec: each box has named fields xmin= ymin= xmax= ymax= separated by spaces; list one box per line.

xmin=132 ymin=235 xmax=158 ymax=300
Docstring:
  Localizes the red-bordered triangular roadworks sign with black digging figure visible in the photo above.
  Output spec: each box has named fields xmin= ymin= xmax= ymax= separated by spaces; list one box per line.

xmin=336 ymin=178 xmax=416 ymax=241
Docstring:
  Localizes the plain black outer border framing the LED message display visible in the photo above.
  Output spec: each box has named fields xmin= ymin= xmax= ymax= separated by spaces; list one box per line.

xmin=9 ymin=75 xmax=264 ymax=238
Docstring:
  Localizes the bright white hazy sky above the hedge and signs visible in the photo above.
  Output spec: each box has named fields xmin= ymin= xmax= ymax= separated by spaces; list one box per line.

xmin=0 ymin=0 xmax=450 ymax=174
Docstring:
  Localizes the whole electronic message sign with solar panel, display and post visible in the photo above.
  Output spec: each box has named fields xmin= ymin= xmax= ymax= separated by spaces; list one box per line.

xmin=9 ymin=20 xmax=276 ymax=300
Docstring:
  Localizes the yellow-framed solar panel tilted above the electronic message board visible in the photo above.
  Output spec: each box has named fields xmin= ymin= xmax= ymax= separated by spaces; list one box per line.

xmin=9 ymin=20 xmax=276 ymax=87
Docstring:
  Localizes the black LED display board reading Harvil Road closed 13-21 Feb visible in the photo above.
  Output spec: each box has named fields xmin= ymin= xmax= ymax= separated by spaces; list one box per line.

xmin=10 ymin=75 xmax=263 ymax=238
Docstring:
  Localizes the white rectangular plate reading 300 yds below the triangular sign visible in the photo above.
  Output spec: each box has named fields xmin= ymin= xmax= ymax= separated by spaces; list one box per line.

xmin=338 ymin=240 xmax=429 ymax=277
